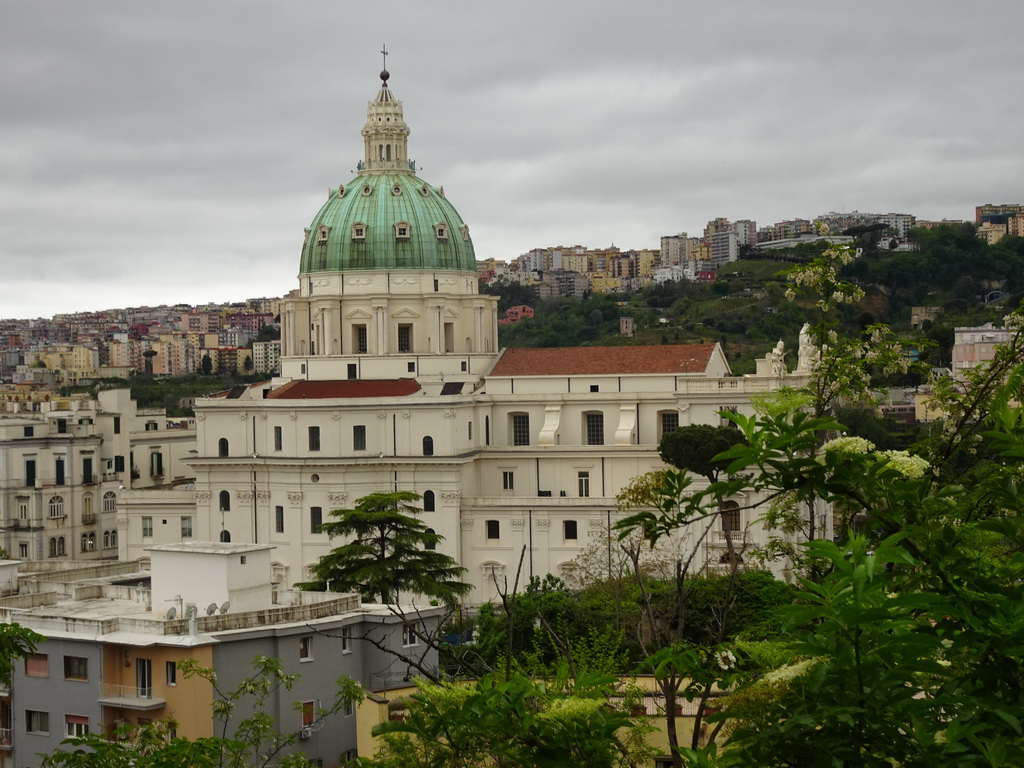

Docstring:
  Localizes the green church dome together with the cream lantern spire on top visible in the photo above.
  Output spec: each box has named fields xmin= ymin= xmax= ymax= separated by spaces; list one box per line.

xmin=299 ymin=72 xmax=476 ymax=274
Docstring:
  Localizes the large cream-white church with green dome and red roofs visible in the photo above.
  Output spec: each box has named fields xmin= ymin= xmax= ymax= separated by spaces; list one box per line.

xmin=120 ymin=72 xmax=806 ymax=603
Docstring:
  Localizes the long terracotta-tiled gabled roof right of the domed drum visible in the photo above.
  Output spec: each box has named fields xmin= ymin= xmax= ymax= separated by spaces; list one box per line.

xmin=489 ymin=344 xmax=715 ymax=376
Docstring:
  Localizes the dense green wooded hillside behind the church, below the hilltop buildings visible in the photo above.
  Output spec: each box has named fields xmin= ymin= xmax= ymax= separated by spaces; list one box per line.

xmin=490 ymin=224 xmax=1024 ymax=373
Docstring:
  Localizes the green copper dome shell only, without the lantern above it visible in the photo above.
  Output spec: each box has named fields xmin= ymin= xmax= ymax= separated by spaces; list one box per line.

xmin=299 ymin=172 xmax=476 ymax=274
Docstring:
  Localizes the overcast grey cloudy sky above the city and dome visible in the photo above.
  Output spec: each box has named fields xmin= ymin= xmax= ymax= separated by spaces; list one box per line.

xmin=0 ymin=0 xmax=1024 ymax=317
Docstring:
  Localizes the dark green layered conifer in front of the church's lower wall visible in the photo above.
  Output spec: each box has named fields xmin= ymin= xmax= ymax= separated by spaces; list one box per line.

xmin=299 ymin=490 xmax=471 ymax=604
